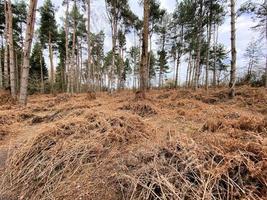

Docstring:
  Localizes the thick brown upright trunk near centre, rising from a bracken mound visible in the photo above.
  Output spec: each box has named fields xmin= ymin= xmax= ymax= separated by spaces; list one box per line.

xmin=140 ymin=0 xmax=149 ymax=98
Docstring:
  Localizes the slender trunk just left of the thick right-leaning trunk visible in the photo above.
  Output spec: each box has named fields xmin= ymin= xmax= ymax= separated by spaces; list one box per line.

xmin=8 ymin=0 xmax=17 ymax=99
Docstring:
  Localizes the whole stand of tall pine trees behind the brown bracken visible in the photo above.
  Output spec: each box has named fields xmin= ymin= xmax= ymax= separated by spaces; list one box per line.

xmin=0 ymin=0 xmax=267 ymax=103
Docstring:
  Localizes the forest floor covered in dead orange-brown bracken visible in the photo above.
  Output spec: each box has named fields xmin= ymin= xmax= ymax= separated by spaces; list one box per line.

xmin=0 ymin=86 xmax=267 ymax=200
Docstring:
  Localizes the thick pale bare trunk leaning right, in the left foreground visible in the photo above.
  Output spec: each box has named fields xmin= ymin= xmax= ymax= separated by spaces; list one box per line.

xmin=19 ymin=0 xmax=37 ymax=105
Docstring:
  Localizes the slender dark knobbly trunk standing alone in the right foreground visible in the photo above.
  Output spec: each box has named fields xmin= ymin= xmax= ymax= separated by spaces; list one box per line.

xmin=229 ymin=0 xmax=236 ymax=98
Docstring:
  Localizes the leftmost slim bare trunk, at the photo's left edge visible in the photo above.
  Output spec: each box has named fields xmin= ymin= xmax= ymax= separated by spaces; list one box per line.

xmin=4 ymin=1 xmax=9 ymax=88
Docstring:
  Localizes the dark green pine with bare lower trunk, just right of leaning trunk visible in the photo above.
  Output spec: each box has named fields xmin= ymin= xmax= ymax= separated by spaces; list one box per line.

xmin=40 ymin=0 xmax=58 ymax=93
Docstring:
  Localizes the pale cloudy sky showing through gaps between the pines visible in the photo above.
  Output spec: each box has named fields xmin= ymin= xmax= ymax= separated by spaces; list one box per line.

xmin=37 ymin=0 xmax=266 ymax=83
